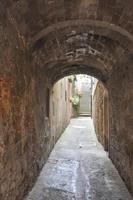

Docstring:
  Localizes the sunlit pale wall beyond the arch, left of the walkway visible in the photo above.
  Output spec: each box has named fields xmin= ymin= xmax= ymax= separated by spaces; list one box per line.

xmin=50 ymin=77 xmax=72 ymax=142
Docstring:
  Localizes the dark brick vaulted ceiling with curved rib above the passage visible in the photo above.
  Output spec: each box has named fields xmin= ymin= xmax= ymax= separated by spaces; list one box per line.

xmin=7 ymin=0 xmax=133 ymax=82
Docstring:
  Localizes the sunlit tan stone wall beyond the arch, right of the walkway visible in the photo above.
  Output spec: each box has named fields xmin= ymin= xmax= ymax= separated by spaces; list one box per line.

xmin=92 ymin=81 xmax=109 ymax=150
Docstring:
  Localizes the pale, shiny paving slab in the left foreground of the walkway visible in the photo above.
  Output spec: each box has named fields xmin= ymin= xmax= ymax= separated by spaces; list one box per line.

xmin=41 ymin=159 xmax=79 ymax=193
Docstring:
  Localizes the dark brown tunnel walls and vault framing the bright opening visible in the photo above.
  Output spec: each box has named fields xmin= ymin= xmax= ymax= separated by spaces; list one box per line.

xmin=0 ymin=0 xmax=133 ymax=200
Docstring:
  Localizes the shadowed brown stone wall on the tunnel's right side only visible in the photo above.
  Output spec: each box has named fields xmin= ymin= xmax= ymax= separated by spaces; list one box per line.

xmin=109 ymin=57 xmax=133 ymax=193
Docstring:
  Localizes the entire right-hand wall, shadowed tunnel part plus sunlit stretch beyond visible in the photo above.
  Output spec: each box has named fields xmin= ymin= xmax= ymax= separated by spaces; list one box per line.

xmin=93 ymin=69 xmax=133 ymax=193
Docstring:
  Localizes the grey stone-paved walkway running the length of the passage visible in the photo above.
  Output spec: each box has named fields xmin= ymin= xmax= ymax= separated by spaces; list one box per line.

xmin=26 ymin=118 xmax=133 ymax=200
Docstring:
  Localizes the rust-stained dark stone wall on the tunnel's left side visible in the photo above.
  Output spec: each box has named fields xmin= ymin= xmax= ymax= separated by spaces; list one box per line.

xmin=0 ymin=16 xmax=72 ymax=200
